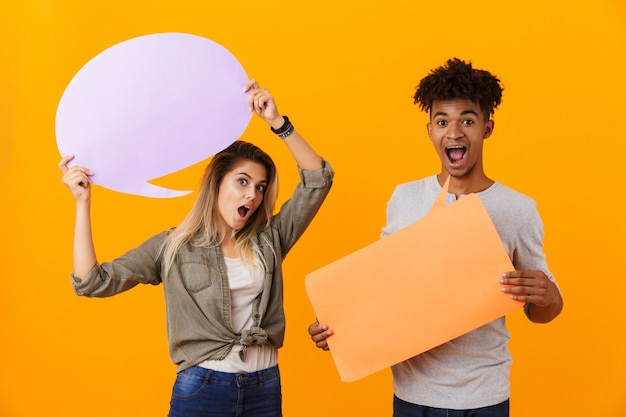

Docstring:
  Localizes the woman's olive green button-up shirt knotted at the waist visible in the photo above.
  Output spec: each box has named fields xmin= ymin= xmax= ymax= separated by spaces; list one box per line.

xmin=72 ymin=161 xmax=334 ymax=372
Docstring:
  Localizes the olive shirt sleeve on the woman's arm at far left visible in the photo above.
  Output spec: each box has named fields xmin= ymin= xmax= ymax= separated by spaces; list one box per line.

xmin=71 ymin=232 xmax=167 ymax=297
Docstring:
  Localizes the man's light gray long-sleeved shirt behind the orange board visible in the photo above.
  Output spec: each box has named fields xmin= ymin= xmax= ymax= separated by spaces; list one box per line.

xmin=382 ymin=176 xmax=554 ymax=410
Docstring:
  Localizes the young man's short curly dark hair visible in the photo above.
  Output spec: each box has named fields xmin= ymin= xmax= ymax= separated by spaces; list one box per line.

xmin=413 ymin=58 xmax=503 ymax=117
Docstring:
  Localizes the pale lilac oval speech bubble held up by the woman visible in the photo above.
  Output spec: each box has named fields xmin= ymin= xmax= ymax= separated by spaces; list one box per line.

xmin=56 ymin=33 xmax=252 ymax=198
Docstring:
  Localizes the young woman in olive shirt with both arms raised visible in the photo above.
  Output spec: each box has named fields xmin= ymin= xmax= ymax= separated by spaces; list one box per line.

xmin=59 ymin=80 xmax=334 ymax=417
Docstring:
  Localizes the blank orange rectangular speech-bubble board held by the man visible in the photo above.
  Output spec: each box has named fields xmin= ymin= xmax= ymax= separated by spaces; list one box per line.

xmin=305 ymin=178 xmax=523 ymax=382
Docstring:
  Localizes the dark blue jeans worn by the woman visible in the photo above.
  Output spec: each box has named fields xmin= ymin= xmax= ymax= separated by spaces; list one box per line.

xmin=168 ymin=366 xmax=282 ymax=417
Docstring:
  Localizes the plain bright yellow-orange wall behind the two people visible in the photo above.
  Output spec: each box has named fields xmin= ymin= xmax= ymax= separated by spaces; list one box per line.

xmin=0 ymin=0 xmax=626 ymax=417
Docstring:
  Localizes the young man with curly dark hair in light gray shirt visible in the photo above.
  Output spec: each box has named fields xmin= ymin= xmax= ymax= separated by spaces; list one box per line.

xmin=309 ymin=58 xmax=563 ymax=417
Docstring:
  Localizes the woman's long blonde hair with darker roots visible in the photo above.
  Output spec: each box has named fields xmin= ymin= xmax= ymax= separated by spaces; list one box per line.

xmin=162 ymin=141 xmax=278 ymax=275
